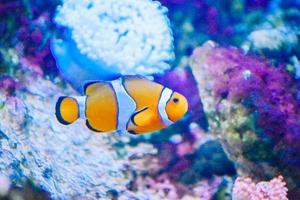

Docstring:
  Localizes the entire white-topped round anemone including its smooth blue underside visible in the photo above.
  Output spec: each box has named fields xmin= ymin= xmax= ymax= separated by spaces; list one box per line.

xmin=52 ymin=0 xmax=174 ymax=91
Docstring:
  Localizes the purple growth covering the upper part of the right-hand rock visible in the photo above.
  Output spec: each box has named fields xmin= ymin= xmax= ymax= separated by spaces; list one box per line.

xmin=192 ymin=43 xmax=300 ymax=165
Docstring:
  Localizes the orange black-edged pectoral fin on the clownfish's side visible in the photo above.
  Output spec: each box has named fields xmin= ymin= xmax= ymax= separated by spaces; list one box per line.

xmin=131 ymin=107 xmax=154 ymax=126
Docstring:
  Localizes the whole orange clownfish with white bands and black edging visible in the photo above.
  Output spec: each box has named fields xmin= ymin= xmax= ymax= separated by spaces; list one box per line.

xmin=56 ymin=76 xmax=188 ymax=134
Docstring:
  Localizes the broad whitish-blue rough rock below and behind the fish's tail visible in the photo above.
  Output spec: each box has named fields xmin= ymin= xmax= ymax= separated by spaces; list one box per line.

xmin=0 ymin=78 xmax=159 ymax=199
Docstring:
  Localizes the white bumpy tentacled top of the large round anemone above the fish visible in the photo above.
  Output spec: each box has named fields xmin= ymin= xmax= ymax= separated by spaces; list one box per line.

xmin=55 ymin=0 xmax=174 ymax=74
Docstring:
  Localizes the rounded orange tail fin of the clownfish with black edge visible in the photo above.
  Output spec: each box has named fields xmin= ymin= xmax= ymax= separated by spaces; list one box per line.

xmin=55 ymin=96 xmax=79 ymax=125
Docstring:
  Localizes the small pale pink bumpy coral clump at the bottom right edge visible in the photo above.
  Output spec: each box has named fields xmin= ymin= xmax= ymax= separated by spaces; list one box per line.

xmin=232 ymin=176 xmax=288 ymax=200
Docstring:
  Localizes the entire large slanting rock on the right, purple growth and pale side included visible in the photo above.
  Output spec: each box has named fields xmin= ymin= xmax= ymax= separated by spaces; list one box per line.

xmin=191 ymin=41 xmax=300 ymax=197
